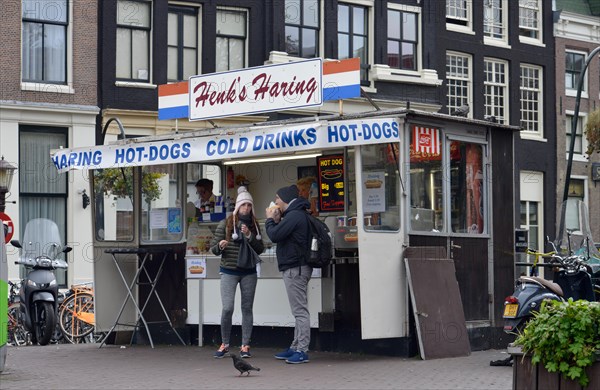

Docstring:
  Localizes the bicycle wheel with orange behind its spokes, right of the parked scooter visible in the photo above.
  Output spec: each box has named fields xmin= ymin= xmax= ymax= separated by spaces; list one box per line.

xmin=58 ymin=293 xmax=95 ymax=342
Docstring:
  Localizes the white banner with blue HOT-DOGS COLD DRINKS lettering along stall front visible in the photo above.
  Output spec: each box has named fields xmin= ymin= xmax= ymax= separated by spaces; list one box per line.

xmin=52 ymin=118 xmax=400 ymax=172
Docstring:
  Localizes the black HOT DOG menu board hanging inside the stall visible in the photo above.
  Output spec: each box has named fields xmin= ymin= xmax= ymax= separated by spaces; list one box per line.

xmin=317 ymin=154 xmax=345 ymax=212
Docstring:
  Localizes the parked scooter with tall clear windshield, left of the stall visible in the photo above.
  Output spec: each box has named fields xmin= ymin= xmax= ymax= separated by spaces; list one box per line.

xmin=11 ymin=218 xmax=72 ymax=345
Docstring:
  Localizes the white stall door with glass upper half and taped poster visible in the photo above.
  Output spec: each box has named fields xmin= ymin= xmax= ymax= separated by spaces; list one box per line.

xmin=355 ymin=143 xmax=408 ymax=339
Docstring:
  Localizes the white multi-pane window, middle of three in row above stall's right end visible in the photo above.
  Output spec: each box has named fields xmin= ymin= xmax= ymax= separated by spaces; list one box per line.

xmin=483 ymin=59 xmax=508 ymax=124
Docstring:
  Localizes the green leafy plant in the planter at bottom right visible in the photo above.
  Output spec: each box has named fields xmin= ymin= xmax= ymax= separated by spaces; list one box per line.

xmin=515 ymin=299 xmax=600 ymax=386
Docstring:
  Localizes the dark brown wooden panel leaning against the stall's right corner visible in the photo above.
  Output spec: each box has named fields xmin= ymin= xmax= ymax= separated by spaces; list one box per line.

xmin=404 ymin=259 xmax=471 ymax=359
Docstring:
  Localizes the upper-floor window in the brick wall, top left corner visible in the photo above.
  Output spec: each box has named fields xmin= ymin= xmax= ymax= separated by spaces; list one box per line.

xmin=21 ymin=0 xmax=69 ymax=84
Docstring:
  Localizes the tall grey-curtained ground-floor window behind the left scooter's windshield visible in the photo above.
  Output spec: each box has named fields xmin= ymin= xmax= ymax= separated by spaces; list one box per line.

xmin=17 ymin=126 xmax=68 ymax=287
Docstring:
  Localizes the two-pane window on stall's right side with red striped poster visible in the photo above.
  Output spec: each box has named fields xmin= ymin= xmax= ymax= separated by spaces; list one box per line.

xmin=410 ymin=125 xmax=487 ymax=234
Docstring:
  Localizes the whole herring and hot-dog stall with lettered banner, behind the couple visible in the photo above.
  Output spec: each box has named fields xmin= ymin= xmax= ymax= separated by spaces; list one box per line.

xmin=52 ymin=110 xmax=514 ymax=356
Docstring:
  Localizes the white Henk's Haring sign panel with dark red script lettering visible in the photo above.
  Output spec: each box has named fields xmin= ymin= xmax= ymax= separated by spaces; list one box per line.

xmin=189 ymin=58 xmax=323 ymax=121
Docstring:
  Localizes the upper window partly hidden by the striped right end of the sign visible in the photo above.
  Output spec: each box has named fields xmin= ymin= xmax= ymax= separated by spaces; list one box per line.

xmin=338 ymin=3 xmax=369 ymax=85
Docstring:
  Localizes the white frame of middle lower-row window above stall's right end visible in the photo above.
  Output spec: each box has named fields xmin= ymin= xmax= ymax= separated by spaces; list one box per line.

xmin=483 ymin=57 xmax=510 ymax=124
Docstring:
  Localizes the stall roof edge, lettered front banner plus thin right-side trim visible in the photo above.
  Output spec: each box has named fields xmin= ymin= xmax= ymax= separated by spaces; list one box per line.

xmin=51 ymin=109 xmax=519 ymax=172
